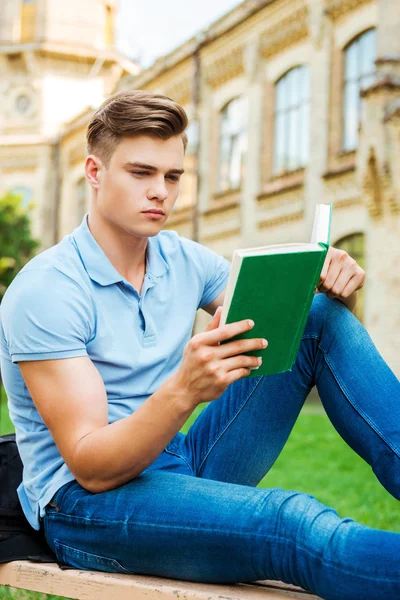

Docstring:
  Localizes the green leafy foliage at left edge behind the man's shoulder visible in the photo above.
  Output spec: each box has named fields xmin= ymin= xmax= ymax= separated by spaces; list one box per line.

xmin=0 ymin=194 xmax=39 ymax=300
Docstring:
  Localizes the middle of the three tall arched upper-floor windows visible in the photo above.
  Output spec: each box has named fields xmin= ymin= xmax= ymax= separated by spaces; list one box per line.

xmin=274 ymin=65 xmax=310 ymax=174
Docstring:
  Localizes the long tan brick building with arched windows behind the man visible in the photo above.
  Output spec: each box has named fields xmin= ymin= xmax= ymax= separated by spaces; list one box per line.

xmin=0 ymin=0 xmax=400 ymax=375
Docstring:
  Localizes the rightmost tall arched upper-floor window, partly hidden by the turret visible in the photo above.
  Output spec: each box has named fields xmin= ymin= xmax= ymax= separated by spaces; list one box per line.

xmin=343 ymin=29 xmax=376 ymax=152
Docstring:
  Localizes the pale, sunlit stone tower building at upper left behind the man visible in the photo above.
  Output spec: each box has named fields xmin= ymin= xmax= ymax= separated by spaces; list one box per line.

xmin=0 ymin=0 xmax=138 ymax=247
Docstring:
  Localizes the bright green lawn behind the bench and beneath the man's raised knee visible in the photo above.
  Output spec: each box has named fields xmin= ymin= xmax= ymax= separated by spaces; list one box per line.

xmin=0 ymin=394 xmax=400 ymax=600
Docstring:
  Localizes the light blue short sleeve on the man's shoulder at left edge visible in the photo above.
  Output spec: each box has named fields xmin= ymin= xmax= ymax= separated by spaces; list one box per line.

xmin=0 ymin=267 xmax=94 ymax=363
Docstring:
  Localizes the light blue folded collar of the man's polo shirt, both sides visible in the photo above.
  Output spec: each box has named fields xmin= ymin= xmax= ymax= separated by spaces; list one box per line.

xmin=71 ymin=214 xmax=168 ymax=286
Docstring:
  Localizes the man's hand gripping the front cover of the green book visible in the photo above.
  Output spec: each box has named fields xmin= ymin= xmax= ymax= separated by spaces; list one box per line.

xmin=172 ymin=307 xmax=267 ymax=406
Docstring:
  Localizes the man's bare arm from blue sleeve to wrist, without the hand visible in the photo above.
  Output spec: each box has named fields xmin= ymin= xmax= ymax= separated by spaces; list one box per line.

xmin=19 ymin=357 xmax=195 ymax=492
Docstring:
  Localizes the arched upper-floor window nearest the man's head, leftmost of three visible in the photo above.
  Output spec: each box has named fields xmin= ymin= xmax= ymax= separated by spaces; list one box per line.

xmin=218 ymin=97 xmax=247 ymax=192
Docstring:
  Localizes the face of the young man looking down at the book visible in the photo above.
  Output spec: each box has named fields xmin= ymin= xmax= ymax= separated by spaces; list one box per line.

xmin=93 ymin=135 xmax=184 ymax=237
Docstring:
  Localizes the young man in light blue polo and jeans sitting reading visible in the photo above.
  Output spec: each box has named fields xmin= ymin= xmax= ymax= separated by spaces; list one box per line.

xmin=0 ymin=91 xmax=400 ymax=600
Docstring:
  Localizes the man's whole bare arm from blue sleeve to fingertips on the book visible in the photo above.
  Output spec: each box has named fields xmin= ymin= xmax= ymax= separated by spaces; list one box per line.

xmin=18 ymin=310 xmax=265 ymax=493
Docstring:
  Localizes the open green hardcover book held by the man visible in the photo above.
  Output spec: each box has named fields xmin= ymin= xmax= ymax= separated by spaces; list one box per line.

xmin=221 ymin=204 xmax=332 ymax=377
